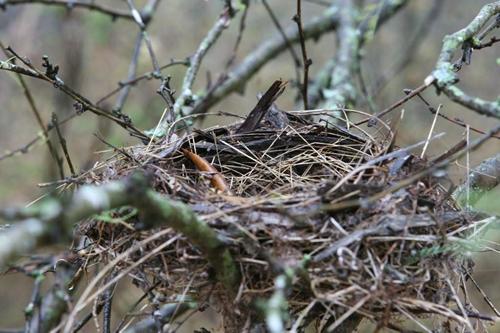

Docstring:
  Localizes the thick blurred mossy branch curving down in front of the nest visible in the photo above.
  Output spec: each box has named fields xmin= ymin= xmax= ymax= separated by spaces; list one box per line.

xmin=0 ymin=174 xmax=240 ymax=293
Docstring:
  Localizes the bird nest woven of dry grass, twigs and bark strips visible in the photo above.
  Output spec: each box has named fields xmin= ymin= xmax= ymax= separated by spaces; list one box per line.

xmin=79 ymin=108 xmax=480 ymax=331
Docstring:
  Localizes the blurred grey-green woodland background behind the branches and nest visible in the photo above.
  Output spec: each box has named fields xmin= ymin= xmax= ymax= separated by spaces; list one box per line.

xmin=0 ymin=0 xmax=500 ymax=332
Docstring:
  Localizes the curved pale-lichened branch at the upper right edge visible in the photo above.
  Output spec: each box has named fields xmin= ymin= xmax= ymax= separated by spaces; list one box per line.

xmin=431 ymin=1 xmax=500 ymax=119
